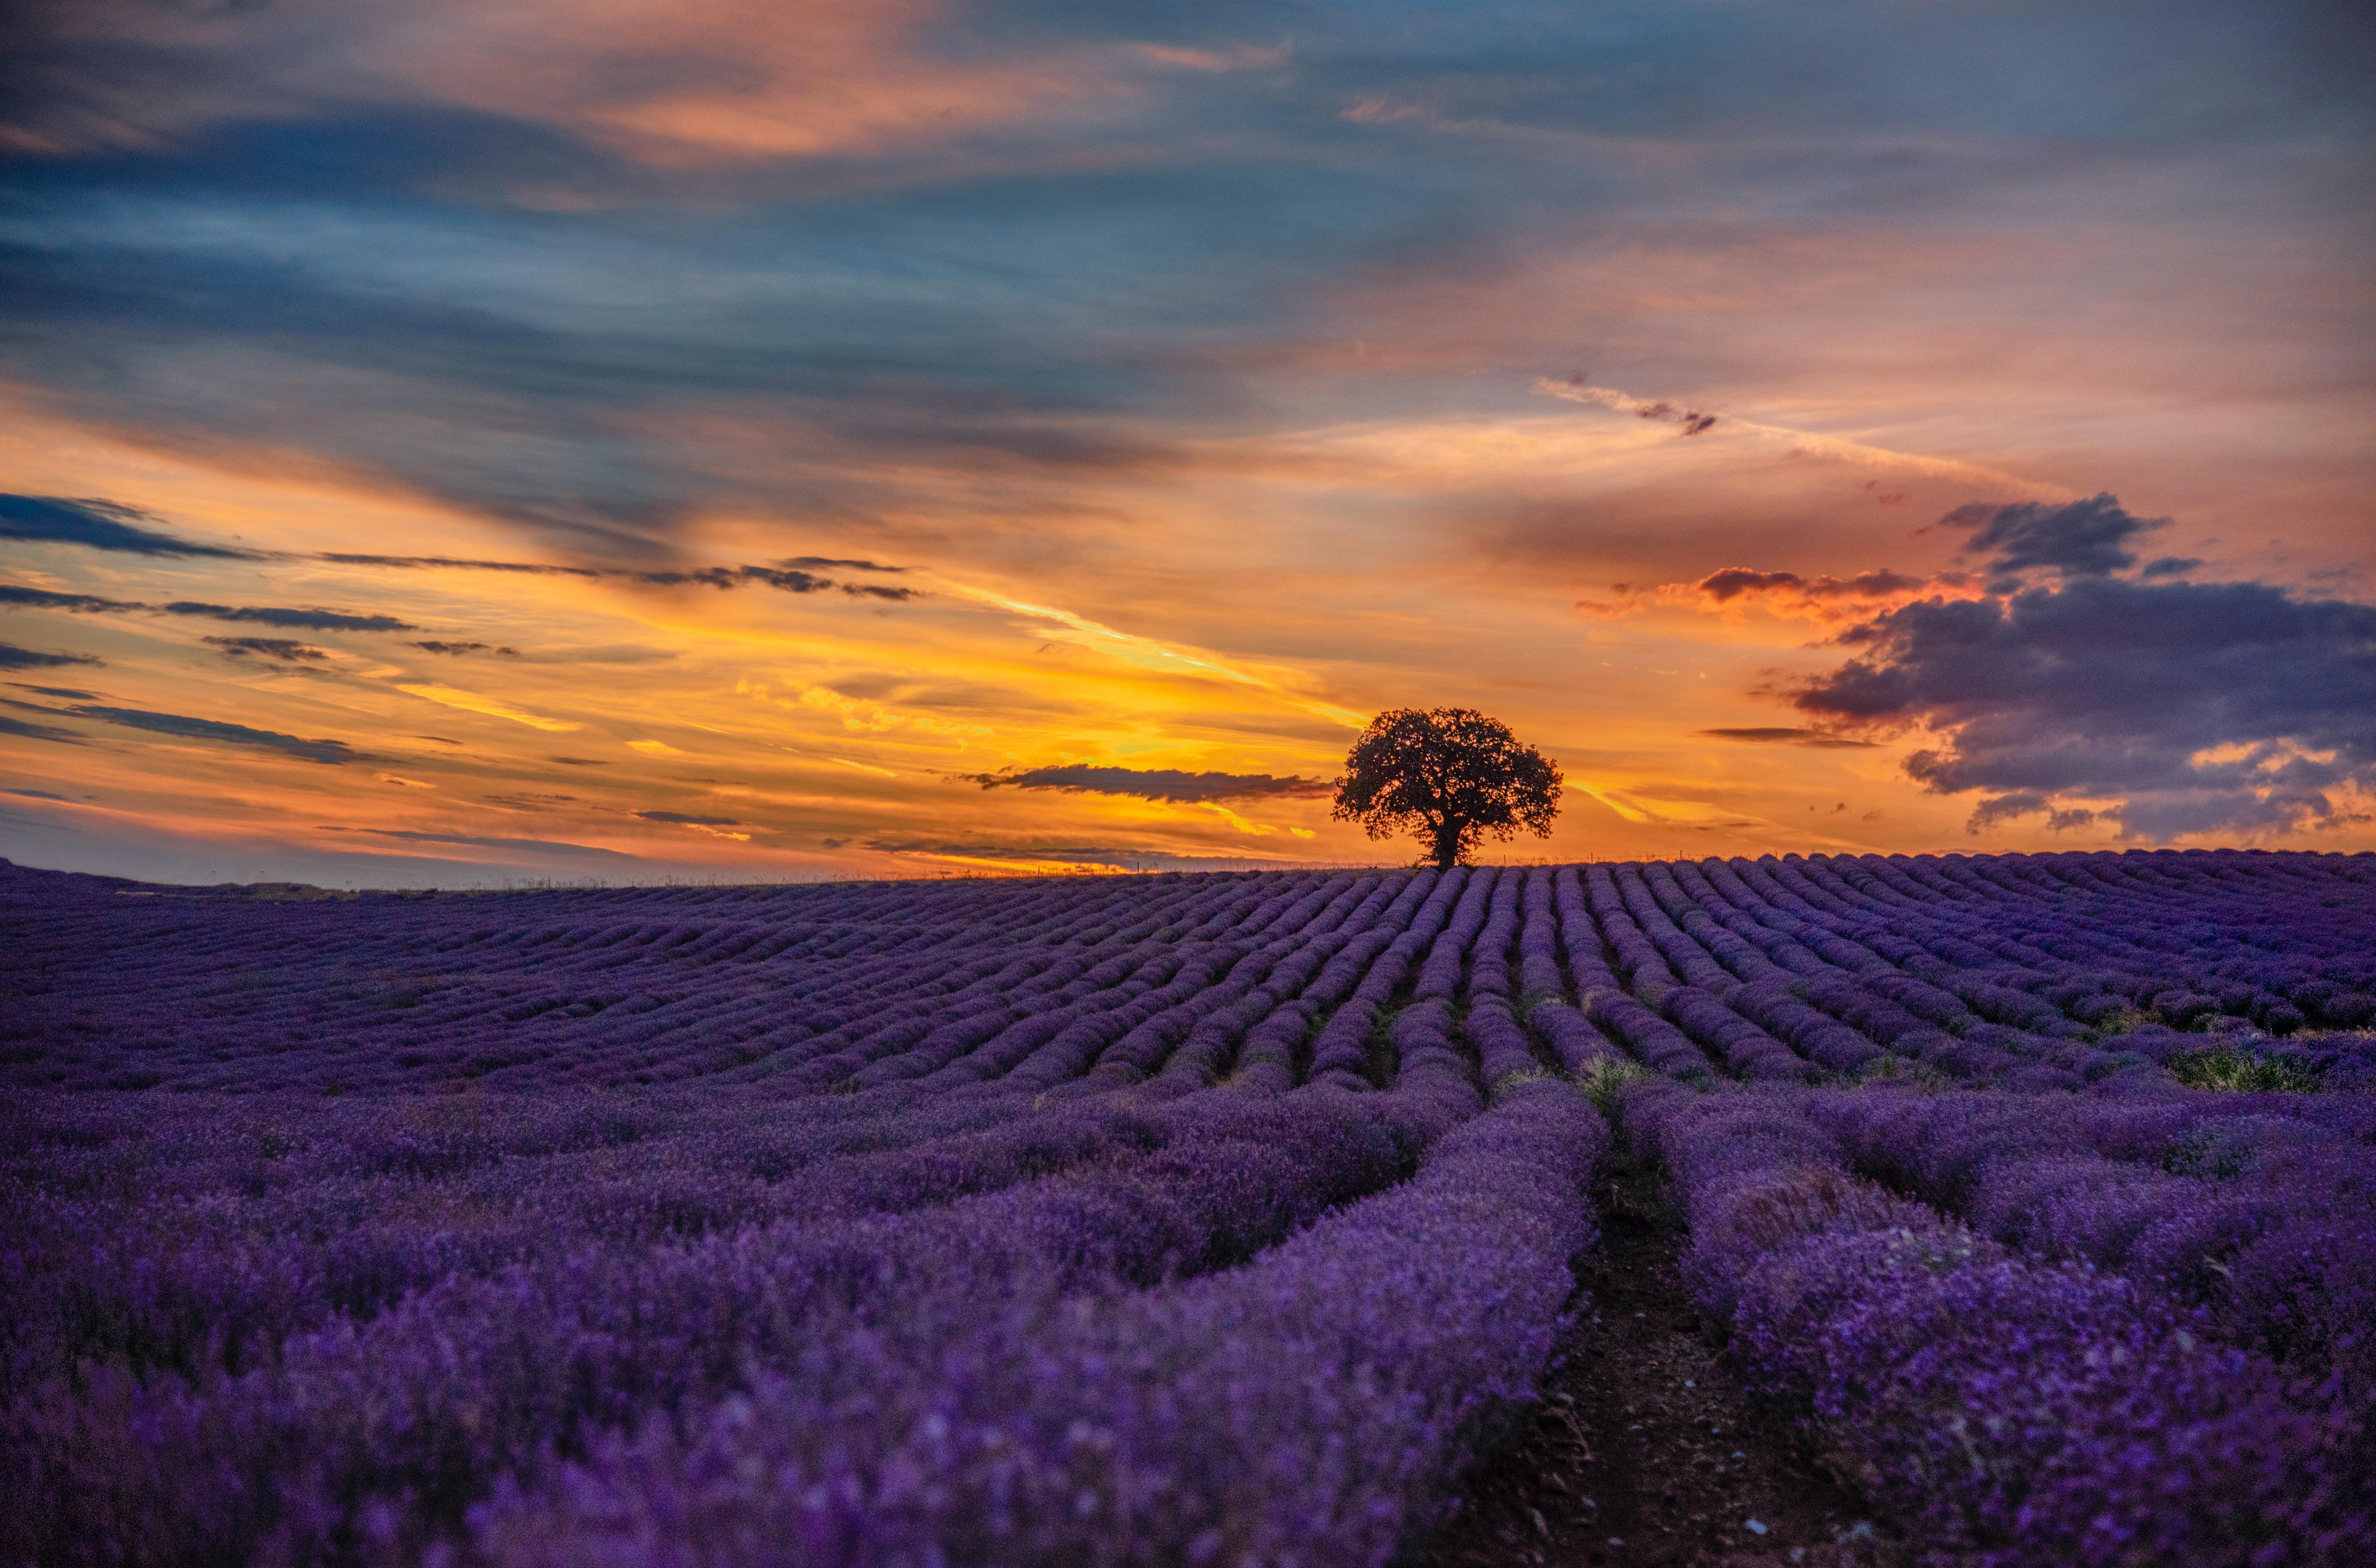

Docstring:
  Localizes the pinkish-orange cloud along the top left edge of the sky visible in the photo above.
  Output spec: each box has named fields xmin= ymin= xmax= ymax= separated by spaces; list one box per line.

xmin=0 ymin=0 xmax=1245 ymax=172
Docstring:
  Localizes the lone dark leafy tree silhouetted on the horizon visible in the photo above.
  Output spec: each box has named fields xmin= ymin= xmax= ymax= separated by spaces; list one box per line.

xmin=1333 ymin=708 xmax=1559 ymax=867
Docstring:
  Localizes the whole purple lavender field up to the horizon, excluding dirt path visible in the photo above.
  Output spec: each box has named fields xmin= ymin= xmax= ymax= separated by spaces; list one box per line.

xmin=0 ymin=850 xmax=2376 ymax=1568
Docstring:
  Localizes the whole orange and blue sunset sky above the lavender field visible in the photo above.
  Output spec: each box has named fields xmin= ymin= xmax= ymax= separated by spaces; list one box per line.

xmin=0 ymin=0 xmax=2376 ymax=886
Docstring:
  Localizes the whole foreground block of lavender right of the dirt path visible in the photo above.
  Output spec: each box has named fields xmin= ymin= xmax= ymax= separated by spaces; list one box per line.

xmin=1623 ymin=1083 xmax=2376 ymax=1568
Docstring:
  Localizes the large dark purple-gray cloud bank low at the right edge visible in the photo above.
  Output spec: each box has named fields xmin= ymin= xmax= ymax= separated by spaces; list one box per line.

xmin=1786 ymin=494 xmax=2376 ymax=841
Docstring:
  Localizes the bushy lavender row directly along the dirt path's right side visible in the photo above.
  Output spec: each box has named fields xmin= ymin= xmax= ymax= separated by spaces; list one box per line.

xmin=1625 ymin=1086 xmax=2376 ymax=1568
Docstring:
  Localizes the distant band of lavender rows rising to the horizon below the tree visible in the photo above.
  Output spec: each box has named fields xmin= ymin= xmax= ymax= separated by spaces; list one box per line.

xmin=18 ymin=853 xmax=2376 ymax=1093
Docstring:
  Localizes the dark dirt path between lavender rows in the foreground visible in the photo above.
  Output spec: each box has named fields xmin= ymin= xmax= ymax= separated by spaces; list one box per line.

xmin=1414 ymin=1155 xmax=1903 ymax=1568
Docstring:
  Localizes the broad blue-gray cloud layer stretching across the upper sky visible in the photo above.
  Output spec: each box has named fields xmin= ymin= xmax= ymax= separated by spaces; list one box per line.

xmin=0 ymin=0 xmax=2369 ymax=570
